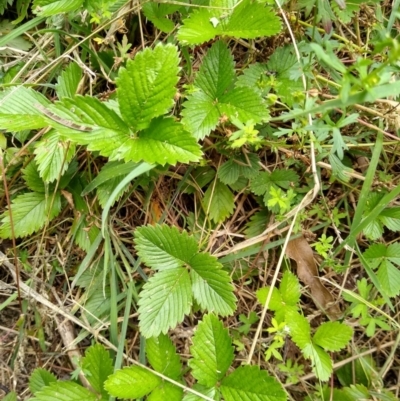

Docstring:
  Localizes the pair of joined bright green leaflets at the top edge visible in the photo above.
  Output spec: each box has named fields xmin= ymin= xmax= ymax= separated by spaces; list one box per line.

xmin=178 ymin=0 xmax=281 ymax=45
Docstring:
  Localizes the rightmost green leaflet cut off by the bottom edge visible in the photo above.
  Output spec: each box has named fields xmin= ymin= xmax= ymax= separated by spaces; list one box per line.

xmin=221 ymin=365 xmax=286 ymax=401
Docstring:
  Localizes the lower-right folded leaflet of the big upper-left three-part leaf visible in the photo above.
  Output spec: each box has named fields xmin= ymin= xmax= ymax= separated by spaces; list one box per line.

xmin=118 ymin=117 xmax=202 ymax=166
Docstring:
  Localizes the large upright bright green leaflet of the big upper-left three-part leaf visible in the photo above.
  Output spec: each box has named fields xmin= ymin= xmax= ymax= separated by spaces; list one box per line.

xmin=117 ymin=44 xmax=179 ymax=131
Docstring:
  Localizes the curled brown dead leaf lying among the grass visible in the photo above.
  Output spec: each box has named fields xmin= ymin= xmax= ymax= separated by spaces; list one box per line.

xmin=286 ymin=237 xmax=342 ymax=320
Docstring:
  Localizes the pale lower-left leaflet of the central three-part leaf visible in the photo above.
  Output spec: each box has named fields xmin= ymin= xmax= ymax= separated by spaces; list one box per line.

xmin=139 ymin=268 xmax=192 ymax=338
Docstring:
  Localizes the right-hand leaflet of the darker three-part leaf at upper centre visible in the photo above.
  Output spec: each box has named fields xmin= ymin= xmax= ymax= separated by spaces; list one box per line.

xmin=219 ymin=86 xmax=269 ymax=123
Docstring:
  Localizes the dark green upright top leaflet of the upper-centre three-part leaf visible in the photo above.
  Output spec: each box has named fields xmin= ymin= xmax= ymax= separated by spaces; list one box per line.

xmin=194 ymin=41 xmax=235 ymax=100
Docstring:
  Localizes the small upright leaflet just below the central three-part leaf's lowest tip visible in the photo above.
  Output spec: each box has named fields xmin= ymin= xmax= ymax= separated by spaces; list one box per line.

xmin=146 ymin=334 xmax=182 ymax=380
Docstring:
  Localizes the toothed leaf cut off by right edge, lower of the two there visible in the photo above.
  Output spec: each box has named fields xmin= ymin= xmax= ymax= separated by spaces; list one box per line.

xmin=364 ymin=242 xmax=400 ymax=297
